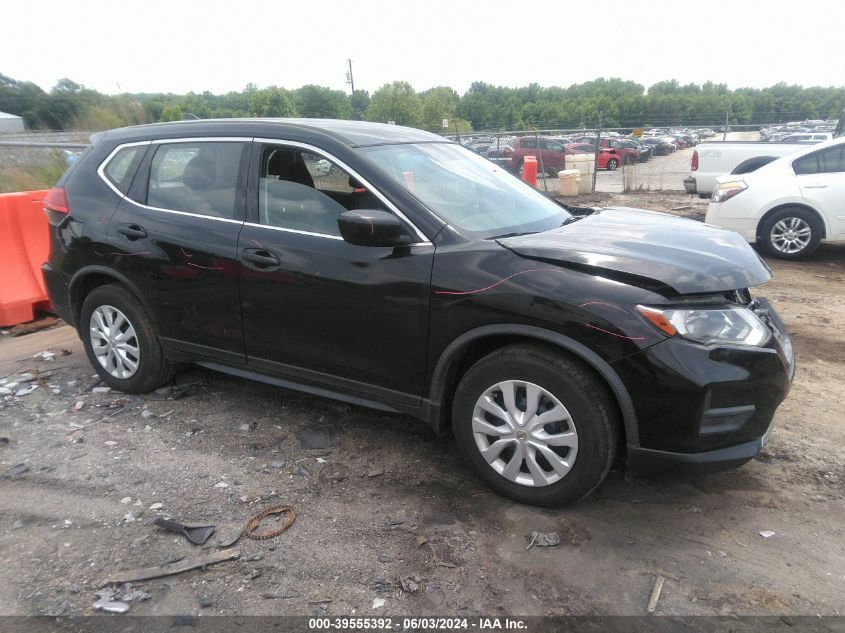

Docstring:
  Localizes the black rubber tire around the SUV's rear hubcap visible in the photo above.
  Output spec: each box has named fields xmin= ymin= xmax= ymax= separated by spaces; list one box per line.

xmin=79 ymin=284 xmax=176 ymax=393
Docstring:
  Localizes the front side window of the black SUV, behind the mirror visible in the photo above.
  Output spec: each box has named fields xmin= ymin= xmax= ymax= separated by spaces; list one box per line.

xmin=258 ymin=146 xmax=385 ymax=236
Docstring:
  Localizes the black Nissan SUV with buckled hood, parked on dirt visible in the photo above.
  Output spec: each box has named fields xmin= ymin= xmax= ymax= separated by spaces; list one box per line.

xmin=44 ymin=119 xmax=794 ymax=505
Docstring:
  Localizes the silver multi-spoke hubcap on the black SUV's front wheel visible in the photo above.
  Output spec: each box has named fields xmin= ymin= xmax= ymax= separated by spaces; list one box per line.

xmin=472 ymin=380 xmax=578 ymax=486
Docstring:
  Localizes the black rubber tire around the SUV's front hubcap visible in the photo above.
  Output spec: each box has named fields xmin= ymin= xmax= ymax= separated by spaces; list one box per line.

xmin=452 ymin=344 xmax=617 ymax=507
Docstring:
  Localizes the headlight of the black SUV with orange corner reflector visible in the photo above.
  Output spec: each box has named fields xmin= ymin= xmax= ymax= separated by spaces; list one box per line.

xmin=637 ymin=306 xmax=770 ymax=345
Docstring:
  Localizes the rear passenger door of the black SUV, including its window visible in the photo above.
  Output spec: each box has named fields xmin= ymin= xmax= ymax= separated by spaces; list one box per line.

xmin=107 ymin=138 xmax=249 ymax=364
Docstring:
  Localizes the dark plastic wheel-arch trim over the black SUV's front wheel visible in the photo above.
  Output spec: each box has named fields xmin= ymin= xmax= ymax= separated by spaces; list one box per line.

xmin=424 ymin=323 xmax=640 ymax=448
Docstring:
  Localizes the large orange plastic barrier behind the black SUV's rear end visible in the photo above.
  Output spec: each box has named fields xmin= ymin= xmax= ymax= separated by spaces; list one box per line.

xmin=0 ymin=191 xmax=50 ymax=326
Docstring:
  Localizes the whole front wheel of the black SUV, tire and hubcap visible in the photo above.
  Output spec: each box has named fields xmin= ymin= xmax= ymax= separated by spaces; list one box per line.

xmin=452 ymin=345 xmax=617 ymax=507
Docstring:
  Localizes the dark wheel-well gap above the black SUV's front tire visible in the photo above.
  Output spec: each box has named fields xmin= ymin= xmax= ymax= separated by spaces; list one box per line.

xmin=436 ymin=334 xmax=627 ymax=456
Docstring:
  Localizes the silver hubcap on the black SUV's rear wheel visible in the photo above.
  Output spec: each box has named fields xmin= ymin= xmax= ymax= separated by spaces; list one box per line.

xmin=89 ymin=306 xmax=141 ymax=379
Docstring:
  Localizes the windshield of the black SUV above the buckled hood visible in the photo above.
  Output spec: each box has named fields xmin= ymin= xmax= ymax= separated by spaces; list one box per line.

xmin=359 ymin=143 xmax=571 ymax=238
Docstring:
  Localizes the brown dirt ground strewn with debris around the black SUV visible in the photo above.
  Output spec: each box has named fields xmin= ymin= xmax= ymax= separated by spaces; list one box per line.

xmin=0 ymin=194 xmax=845 ymax=616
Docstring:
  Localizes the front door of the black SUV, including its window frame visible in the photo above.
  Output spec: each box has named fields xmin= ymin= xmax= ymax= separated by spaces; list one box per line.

xmin=238 ymin=142 xmax=434 ymax=404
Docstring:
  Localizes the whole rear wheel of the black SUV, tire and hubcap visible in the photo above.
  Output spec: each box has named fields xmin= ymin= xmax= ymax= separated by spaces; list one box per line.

xmin=79 ymin=284 xmax=175 ymax=393
